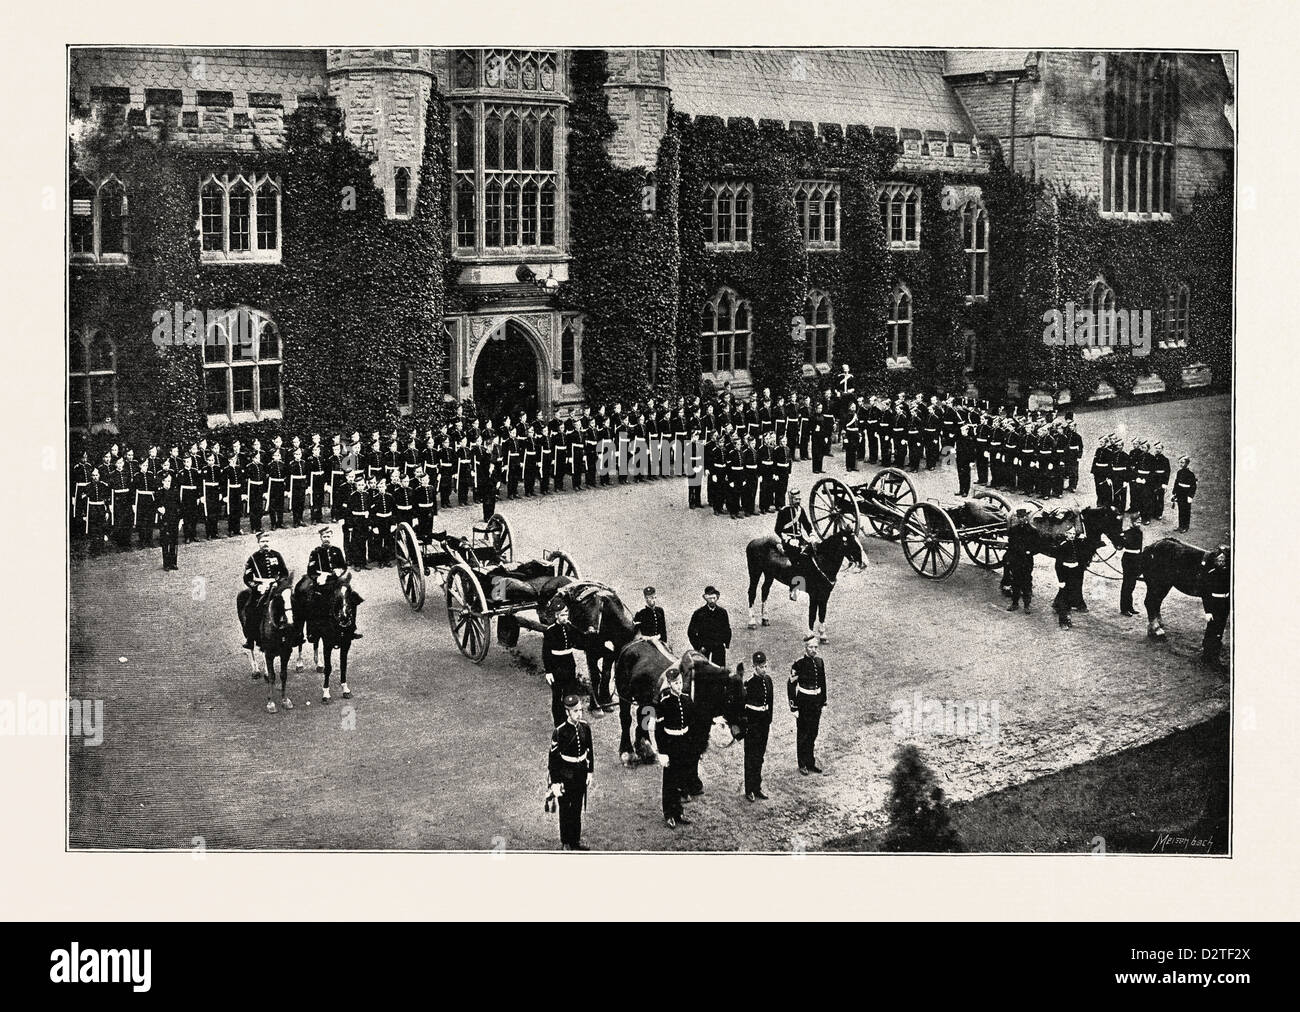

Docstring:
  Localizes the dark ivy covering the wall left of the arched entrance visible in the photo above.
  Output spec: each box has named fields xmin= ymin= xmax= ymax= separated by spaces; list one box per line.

xmin=70 ymin=90 xmax=450 ymax=453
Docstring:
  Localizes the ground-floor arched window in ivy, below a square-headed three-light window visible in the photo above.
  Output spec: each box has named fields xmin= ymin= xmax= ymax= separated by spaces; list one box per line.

xmin=203 ymin=307 xmax=283 ymax=424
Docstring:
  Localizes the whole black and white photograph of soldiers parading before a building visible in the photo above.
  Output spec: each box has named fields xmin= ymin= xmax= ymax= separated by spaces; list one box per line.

xmin=58 ymin=37 xmax=1237 ymax=864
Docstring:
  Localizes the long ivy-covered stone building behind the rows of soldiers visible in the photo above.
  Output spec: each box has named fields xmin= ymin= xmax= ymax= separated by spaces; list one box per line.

xmin=69 ymin=48 xmax=1234 ymax=442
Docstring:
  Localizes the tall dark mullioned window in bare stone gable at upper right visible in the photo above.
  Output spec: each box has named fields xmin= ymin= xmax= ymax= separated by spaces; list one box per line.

xmin=1101 ymin=53 xmax=1178 ymax=217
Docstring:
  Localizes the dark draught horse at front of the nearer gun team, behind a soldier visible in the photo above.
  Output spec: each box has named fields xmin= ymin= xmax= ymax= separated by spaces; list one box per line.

xmin=614 ymin=639 xmax=744 ymax=775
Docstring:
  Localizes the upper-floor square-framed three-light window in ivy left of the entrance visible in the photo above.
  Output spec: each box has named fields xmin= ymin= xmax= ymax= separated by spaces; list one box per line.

xmin=199 ymin=174 xmax=281 ymax=263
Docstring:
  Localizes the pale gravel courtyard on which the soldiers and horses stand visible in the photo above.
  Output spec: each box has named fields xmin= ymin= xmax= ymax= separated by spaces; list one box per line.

xmin=69 ymin=397 xmax=1232 ymax=851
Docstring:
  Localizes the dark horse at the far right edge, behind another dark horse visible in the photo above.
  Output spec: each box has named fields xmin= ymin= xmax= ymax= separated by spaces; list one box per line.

xmin=1139 ymin=537 xmax=1232 ymax=663
